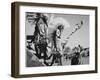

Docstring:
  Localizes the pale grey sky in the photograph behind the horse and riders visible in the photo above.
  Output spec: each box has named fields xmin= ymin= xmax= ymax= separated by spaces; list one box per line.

xmin=25 ymin=13 xmax=89 ymax=48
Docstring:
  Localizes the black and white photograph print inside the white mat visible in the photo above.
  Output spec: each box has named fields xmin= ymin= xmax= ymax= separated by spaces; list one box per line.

xmin=25 ymin=12 xmax=91 ymax=67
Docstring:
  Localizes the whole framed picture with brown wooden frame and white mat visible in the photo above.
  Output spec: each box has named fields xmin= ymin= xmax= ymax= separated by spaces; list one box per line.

xmin=12 ymin=2 xmax=97 ymax=77
